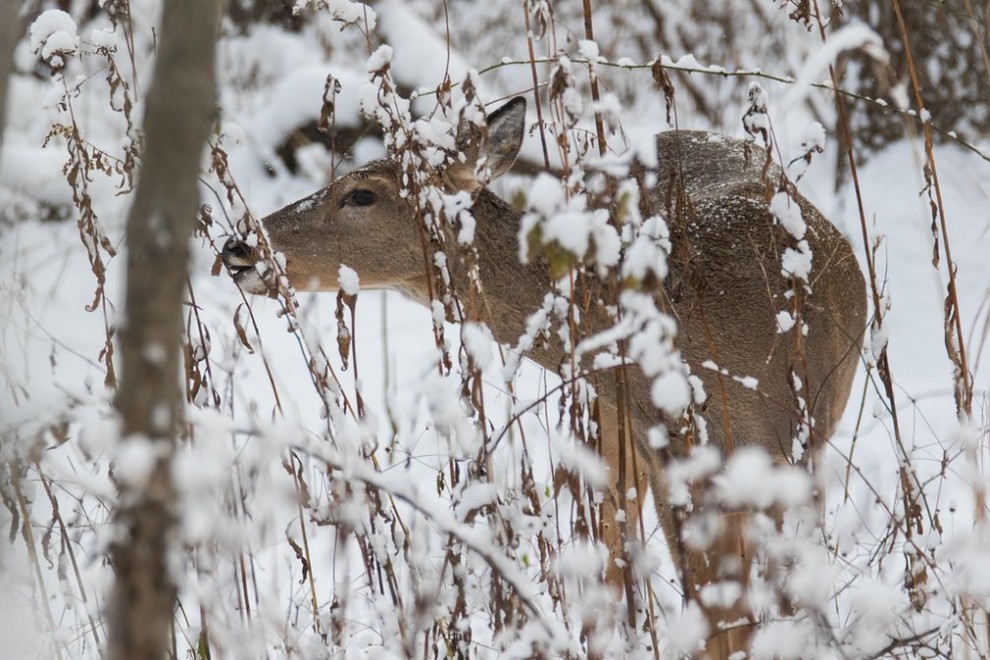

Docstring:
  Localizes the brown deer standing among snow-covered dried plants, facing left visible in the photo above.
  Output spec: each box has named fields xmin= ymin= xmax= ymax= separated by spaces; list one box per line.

xmin=227 ymin=97 xmax=866 ymax=658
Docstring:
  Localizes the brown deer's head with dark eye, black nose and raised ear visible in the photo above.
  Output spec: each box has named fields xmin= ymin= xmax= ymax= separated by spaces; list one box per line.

xmin=223 ymin=97 xmax=526 ymax=298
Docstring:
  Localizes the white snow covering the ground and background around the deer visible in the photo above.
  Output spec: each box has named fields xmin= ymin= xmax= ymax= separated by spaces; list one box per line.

xmin=0 ymin=0 xmax=990 ymax=658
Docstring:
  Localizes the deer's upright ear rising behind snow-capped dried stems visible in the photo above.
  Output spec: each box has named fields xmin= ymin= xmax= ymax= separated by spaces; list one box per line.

xmin=447 ymin=96 xmax=526 ymax=190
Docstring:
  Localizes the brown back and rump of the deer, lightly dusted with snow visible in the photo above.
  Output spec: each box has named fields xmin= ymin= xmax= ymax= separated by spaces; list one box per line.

xmin=651 ymin=131 xmax=866 ymax=459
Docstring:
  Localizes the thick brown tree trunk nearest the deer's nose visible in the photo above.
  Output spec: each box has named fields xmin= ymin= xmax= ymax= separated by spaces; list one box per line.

xmin=109 ymin=0 xmax=220 ymax=660
